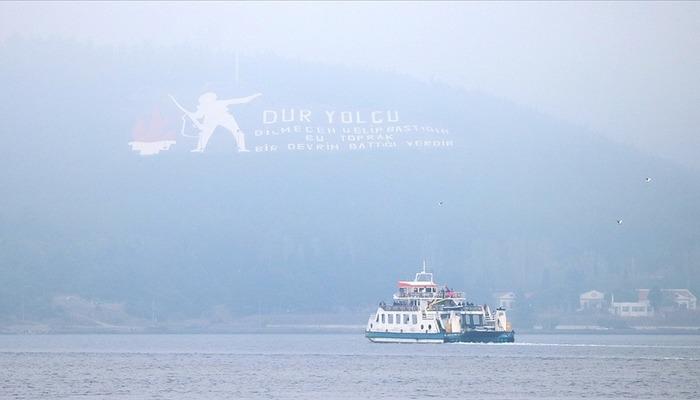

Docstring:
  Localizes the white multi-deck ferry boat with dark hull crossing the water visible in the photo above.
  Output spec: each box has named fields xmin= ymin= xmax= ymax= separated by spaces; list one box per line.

xmin=365 ymin=262 xmax=515 ymax=343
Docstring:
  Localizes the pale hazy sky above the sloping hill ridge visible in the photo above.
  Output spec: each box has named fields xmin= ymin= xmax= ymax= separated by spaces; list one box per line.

xmin=0 ymin=2 xmax=700 ymax=169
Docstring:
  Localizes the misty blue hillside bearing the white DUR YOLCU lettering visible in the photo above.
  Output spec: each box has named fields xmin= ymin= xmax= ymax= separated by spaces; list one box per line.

xmin=0 ymin=40 xmax=700 ymax=317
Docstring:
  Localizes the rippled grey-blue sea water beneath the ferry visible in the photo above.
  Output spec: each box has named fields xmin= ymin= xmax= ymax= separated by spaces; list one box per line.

xmin=0 ymin=334 xmax=700 ymax=399
